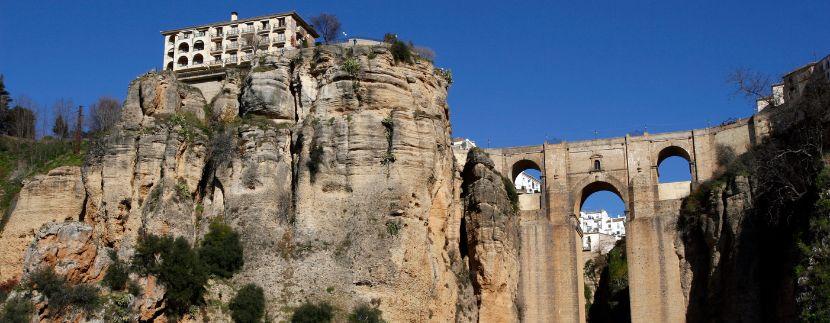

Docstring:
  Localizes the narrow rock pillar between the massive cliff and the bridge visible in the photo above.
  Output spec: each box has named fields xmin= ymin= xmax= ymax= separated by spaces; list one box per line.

xmin=461 ymin=149 xmax=519 ymax=322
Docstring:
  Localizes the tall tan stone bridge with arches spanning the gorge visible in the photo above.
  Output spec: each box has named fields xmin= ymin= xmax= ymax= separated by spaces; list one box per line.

xmin=485 ymin=115 xmax=780 ymax=322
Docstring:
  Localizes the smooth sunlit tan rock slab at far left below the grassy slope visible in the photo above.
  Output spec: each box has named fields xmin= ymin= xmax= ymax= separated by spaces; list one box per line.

xmin=0 ymin=166 xmax=85 ymax=280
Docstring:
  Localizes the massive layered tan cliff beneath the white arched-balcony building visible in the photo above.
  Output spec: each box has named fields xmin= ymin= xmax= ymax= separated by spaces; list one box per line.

xmin=3 ymin=45 xmax=494 ymax=322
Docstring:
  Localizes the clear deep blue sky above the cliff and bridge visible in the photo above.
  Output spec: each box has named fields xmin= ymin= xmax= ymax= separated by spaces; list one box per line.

xmin=0 ymin=0 xmax=830 ymax=218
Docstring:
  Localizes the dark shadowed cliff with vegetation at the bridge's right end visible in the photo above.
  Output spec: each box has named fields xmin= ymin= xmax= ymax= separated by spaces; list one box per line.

xmin=678 ymin=72 xmax=830 ymax=322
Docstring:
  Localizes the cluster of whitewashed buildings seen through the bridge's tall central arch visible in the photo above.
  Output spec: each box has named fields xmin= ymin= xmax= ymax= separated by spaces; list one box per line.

xmin=579 ymin=210 xmax=625 ymax=254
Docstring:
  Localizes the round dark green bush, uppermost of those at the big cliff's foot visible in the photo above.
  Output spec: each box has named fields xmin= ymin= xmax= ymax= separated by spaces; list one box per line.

xmin=199 ymin=221 xmax=244 ymax=278
